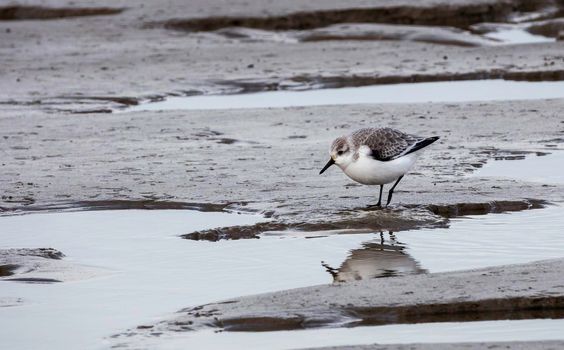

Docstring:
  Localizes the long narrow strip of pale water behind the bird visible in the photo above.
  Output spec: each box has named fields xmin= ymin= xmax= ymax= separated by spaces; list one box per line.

xmin=124 ymin=80 xmax=564 ymax=112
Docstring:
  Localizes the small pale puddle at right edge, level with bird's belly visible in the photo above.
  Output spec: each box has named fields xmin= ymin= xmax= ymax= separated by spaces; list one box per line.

xmin=472 ymin=151 xmax=564 ymax=184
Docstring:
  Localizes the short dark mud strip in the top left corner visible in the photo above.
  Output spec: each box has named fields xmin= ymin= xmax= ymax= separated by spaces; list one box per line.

xmin=0 ymin=5 xmax=125 ymax=21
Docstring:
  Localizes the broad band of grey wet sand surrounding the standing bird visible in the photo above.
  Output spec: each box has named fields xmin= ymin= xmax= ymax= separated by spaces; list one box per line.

xmin=0 ymin=100 xmax=564 ymax=230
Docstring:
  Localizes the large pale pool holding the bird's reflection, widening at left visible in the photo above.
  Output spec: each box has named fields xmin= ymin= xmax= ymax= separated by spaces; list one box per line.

xmin=0 ymin=207 xmax=564 ymax=349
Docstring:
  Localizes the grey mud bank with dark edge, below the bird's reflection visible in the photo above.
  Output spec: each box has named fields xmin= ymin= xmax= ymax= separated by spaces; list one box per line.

xmin=117 ymin=259 xmax=564 ymax=336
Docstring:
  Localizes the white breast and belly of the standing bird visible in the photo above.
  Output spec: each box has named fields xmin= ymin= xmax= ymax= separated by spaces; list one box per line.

xmin=342 ymin=152 xmax=418 ymax=185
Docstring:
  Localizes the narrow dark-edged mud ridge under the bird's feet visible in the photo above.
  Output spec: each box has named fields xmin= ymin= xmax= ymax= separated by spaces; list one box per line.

xmin=181 ymin=199 xmax=548 ymax=242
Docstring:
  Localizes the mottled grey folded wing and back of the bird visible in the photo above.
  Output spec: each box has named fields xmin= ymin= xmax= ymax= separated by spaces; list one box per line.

xmin=351 ymin=128 xmax=425 ymax=161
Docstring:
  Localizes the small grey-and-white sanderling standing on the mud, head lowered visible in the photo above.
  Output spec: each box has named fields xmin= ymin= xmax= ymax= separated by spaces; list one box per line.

xmin=319 ymin=128 xmax=439 ymax=207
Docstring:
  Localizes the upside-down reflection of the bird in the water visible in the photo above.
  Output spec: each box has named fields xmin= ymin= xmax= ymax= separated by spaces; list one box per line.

xmin=322 ymin=232 xmax=427 ymax=283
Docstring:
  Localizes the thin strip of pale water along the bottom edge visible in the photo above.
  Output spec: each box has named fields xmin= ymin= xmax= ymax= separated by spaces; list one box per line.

xmin=133 ymin=319 xmax=564 ymax=350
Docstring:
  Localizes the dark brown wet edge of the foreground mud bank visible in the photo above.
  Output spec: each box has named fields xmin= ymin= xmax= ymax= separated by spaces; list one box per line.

xmin=218 ymin=296 xmax=564 ymax=332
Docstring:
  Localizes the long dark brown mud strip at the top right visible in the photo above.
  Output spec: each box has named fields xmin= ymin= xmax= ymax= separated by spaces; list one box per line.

xmin=155 ymin=1 xmax=547 ymax=32
